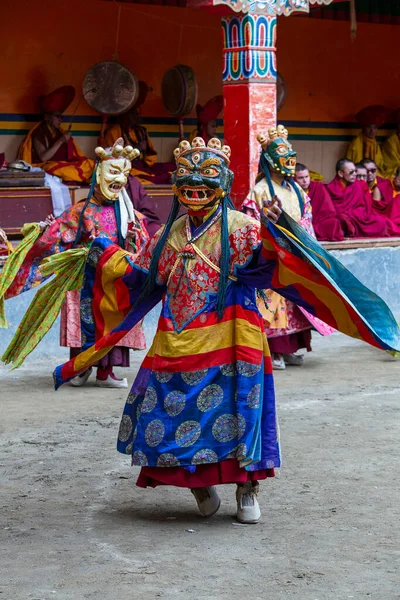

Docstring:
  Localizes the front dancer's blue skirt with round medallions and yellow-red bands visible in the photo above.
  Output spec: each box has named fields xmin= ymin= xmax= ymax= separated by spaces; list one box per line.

xmin=117 ymin=296 xmax=280 ymax=470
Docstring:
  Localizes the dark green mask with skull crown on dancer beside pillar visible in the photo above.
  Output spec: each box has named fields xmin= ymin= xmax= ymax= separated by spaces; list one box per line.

xmin=257 ymin=125 xmax=297 ymax=177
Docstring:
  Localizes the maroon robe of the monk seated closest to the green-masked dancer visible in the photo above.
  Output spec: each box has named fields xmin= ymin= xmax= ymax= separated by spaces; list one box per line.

xmin=308 ymin=181 xmax=344 ymax=242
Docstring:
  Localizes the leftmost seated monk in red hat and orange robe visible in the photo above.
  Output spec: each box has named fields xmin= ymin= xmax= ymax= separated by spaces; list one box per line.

xmin=18 ymin=85 xmax=94 ymax=183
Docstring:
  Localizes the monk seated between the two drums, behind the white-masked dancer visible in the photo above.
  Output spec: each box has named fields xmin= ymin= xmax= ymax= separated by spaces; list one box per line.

xmin=103 ymin=81 xmax=176 ymax=185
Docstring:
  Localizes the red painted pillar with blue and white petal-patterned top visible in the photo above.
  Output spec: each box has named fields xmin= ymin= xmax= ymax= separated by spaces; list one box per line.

xmin=222 ymin=14 xmax=276 ymax=207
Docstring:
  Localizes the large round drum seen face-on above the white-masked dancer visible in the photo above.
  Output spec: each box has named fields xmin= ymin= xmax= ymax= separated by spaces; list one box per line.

xmin=82 ymin=60 xmax=139 ymax=115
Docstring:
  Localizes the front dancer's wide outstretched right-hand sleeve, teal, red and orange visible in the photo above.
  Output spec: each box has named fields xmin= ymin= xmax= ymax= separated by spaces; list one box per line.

xmin=261 ymin=213 xmax=400 ymax=351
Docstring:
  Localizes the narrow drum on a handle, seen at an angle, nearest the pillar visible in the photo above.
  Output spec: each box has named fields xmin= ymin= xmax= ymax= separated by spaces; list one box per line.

xmin=161 ymin=65 xmax=197 ymax=139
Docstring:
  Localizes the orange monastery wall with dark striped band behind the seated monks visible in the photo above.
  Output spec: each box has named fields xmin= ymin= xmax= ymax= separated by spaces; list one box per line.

xmin=0 ymin=0 xmax=400 ymax=180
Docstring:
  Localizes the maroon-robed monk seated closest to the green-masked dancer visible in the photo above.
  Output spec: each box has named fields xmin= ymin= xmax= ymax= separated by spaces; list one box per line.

xmin=295 ymin=163 xmax=344 ymax=242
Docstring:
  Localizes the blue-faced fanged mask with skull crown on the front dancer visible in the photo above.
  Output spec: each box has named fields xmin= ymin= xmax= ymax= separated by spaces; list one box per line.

xmin=172 ymin=137 xmax=233 ymax=213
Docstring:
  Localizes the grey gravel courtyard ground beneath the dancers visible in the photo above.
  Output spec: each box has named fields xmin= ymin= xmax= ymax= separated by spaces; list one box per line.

xmin=0 ymin=334 xmax=400 ymax=600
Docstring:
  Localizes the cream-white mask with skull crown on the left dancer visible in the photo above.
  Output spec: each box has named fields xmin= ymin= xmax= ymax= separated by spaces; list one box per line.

xmin=95 ymin=138 xmax=140 ymax=202
